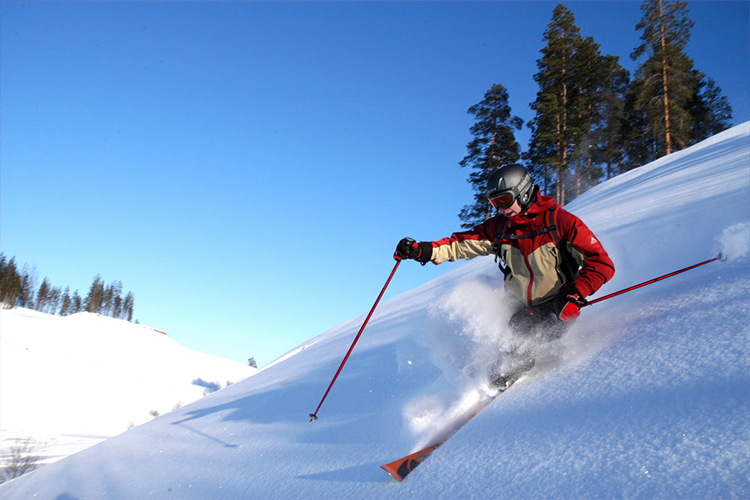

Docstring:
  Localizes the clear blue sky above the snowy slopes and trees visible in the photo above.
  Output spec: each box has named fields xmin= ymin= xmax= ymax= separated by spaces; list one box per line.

xmin=0 ymin=1 xmax=750 ymax=364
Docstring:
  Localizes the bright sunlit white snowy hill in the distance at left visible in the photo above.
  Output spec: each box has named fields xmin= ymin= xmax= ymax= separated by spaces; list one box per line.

xmin=0 ymin=308 xmax=255 ymax=462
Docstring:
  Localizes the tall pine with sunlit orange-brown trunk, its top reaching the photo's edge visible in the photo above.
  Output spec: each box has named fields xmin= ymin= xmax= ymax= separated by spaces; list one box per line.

xmin=631 ymin=0 xmax=697 ymax=156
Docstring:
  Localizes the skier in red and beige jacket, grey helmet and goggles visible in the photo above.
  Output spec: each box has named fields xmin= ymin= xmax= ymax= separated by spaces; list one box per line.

xmin=394 ymin=164 xmax=615 ymax=391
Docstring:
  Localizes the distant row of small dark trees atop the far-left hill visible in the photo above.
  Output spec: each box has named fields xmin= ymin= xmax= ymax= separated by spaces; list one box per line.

xmin=0 ymin=253 xmax=135 ymax=321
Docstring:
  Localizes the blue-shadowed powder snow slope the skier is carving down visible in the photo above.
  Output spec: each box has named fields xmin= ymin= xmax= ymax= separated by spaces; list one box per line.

xmin=0 ymin=123 xmax=750 ymax=500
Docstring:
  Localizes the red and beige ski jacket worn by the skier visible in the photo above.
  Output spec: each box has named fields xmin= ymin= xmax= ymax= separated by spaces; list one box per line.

xmin=431 ymin=195 xmax=615 ymax=307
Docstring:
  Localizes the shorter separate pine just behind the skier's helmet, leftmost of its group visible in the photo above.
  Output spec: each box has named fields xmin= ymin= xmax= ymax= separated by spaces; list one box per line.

xmin=459 ymin=84 xmax=523 ymax=228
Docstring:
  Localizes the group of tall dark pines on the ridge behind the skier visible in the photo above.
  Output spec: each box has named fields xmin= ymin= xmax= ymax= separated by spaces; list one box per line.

xmin=459 ymin=0 xmax=732 ymax=228
